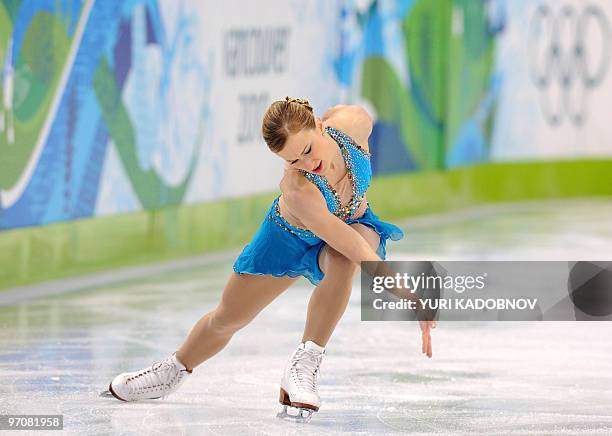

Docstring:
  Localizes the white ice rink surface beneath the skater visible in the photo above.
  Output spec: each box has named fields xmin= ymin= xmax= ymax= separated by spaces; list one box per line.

xmin=0 ymin=200 xmax=612 ymax=435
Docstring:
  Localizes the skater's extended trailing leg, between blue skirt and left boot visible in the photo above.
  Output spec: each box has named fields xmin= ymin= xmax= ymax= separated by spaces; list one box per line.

xmin=176 ymin=272 xmax=297 ymax=369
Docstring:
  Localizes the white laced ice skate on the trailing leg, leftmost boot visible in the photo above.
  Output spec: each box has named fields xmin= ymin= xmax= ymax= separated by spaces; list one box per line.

xmin=101 ymin=353 xmax=192 ymax=401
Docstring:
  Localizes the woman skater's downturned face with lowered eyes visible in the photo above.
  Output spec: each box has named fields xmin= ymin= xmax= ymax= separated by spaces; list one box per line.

xmin=277 ymin=118 xmax=335 ymax=175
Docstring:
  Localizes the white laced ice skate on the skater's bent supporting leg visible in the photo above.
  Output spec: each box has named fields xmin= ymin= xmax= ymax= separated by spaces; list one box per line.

xmin=277 ymin=341 xmax=325 ymax=422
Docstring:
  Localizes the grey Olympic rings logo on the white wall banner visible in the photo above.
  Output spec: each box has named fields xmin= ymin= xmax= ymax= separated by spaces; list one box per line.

xmin=528 ymin=4 xmax=612 ymax=126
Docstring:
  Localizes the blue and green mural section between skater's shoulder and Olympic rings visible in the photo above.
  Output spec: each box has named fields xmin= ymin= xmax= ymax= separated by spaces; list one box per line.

xmin=336 ymin=0 xmax=504 ymax=173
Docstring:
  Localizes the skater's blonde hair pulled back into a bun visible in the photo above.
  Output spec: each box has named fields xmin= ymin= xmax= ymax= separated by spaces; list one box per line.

xmin=261 ymin=97 xmax=316 ymax=153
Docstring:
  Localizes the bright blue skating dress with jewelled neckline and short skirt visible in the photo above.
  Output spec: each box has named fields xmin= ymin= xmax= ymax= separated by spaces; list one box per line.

xmin=234 ymin=127 xmax=404 ymax=285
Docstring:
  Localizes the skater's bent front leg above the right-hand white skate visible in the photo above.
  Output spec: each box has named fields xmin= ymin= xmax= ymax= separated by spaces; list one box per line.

xmin=302 ymin=224 xmax=380 ymax=347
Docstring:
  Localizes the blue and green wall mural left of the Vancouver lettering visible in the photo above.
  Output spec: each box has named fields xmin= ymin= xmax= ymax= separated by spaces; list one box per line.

xmin=0 ymin=0 xmax=210 ymax=229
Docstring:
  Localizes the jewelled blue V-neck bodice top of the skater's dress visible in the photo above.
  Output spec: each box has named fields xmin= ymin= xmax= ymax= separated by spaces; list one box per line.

xmin=300 ymin=127 xmax=372 ymax=220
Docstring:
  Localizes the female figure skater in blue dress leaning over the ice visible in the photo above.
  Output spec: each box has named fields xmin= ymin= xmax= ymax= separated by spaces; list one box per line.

xmin=109 ymin=97 xmax=435 ymax=419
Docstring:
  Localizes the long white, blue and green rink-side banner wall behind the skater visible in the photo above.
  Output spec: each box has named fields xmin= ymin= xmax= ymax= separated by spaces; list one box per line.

xmin=0 ymin=0 xmax=612 ymax=237
